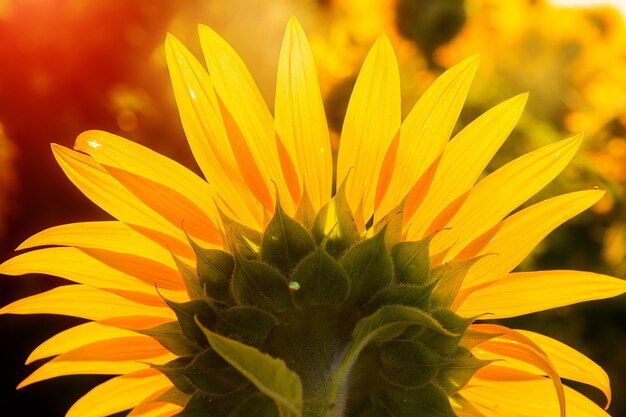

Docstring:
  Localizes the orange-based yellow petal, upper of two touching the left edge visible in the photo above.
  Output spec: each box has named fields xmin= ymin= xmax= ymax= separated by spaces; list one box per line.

xmin=0 ymin=247 xmax=184 ymax=300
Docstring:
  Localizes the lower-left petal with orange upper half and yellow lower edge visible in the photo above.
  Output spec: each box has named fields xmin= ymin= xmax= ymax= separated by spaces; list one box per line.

xmin=18 ymin=336 xmax=176 ymax=389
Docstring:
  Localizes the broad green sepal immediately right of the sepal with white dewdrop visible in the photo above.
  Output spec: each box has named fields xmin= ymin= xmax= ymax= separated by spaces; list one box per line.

xmin=340 ymin=229 xmax=393 ymax=305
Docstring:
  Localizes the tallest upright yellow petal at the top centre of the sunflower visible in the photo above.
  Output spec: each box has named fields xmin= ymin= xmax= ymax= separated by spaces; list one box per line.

xmin=274 ymin=17 xmax=333 ymax=212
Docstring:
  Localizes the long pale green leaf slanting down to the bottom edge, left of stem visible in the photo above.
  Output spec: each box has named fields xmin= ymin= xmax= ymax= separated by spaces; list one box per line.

xmin=197 ymin=321 xmax=302 ymax=417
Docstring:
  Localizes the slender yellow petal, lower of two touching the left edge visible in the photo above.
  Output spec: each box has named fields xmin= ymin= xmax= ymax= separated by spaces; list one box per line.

xmin=0 ymin=284 xmax=176 ymax=320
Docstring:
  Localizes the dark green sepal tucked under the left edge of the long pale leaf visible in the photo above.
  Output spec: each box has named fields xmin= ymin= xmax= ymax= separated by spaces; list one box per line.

xmin=174 ymin=349 xmax=249 ymax=397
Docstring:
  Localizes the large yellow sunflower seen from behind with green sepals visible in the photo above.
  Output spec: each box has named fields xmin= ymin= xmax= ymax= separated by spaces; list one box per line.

xmin=0 ymin=18 xmax=626 ymax=417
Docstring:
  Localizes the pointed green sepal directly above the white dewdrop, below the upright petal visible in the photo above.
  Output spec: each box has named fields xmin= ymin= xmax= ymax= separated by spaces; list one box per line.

xmin=261 ymin=193 xmax=315 ymax=275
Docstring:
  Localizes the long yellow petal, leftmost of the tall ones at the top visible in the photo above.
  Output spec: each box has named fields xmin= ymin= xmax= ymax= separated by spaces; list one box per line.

xmin=165 ymin=35 xmax=263 ymax=229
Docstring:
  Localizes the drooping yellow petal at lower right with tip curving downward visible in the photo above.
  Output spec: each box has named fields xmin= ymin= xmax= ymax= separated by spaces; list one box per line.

xmin=517 ymin=330 xmax=611 ymax=408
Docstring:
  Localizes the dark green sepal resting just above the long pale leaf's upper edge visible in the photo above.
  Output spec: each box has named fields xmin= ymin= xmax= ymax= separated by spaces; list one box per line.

xmin=213 ymin=306 xmax=278 ymax=347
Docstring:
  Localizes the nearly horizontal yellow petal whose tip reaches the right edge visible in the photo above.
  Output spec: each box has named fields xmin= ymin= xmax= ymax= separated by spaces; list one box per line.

xmin=457 ymin=270 xmax=626 ymax=318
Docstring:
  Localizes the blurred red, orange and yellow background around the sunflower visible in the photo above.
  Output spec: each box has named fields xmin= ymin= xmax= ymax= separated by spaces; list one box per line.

xmin=0 ymin=0 xmax=626 ymax=416
